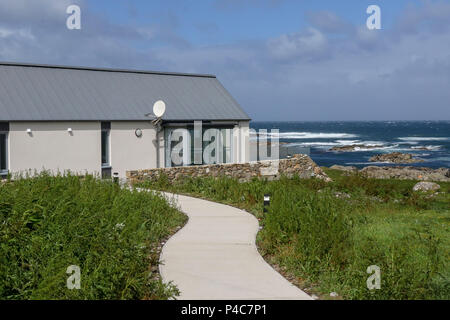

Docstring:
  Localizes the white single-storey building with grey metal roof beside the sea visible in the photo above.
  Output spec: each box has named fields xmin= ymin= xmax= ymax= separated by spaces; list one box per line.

xmin=0 ymin=63 xmax=250 ymax=177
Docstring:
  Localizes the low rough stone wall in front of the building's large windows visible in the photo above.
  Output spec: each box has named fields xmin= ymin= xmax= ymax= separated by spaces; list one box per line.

xmin=127 ymin=155 xmax=331 ymax=184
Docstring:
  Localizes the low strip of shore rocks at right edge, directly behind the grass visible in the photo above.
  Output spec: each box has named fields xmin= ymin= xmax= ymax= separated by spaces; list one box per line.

xmin=359 ymin=166 xmax=450 ymax=181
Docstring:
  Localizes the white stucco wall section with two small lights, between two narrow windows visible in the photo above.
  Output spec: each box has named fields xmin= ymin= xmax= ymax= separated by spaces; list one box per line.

xmin=8 ymin=122 xmax=101 ymax=174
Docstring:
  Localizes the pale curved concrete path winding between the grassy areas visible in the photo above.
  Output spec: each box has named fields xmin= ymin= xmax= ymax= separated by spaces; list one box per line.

xmin=160 ymin=193 xmax=312 ymax=300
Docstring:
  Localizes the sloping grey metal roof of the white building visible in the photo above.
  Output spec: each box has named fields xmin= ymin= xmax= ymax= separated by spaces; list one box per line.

xmin=0 ymin=62 xmax=250 ymax=121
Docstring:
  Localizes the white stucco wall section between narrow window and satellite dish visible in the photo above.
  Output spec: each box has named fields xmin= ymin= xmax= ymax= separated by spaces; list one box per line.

xmin=110 ymin=121 xmax=157 ymax=178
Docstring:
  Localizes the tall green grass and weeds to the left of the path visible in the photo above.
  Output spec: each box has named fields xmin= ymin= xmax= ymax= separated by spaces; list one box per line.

xmin=0 ymin=173 xmax=185 ymax=299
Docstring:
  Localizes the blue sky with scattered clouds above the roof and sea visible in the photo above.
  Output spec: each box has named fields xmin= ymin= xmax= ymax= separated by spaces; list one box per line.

xmin=0 ymin=0 xmax=450 ymax=120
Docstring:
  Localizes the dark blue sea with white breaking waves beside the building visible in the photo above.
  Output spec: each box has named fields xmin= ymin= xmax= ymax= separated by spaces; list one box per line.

xmin=250 ymin=121 xmax=450 ymax=168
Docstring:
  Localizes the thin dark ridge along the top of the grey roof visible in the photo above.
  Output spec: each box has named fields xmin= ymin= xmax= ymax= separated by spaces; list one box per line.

xmin=0 ymin=61 xmax=216 ymax=78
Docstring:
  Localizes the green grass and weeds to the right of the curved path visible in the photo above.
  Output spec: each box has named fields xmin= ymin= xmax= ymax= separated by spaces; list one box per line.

xmin=139 ymin=170 xmax=450 ymax=299
